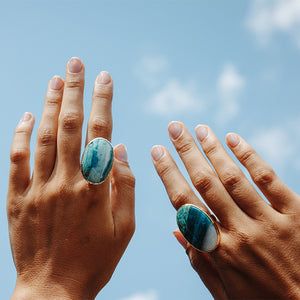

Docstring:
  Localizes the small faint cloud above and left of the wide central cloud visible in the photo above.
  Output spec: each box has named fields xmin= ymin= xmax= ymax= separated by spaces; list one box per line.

xmin=135 ymin=56 xmax=169 ymax=88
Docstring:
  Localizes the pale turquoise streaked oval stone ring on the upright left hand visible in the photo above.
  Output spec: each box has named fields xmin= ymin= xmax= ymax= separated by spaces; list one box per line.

xmin=81 ymin=138 xmax=114 ymax=184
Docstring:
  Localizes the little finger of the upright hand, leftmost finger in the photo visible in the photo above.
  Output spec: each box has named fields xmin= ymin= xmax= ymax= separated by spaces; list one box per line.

xmin=9 ymin=113 xmax=34 ymax=194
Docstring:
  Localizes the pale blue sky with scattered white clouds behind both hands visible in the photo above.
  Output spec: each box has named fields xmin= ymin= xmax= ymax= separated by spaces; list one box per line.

xmin=0 ymin=0 xmax=300 ymax=300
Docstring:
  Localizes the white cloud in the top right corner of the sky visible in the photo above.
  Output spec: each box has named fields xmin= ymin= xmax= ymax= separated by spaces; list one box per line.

xmin=246 ymin=0 xmax=300 ymax=43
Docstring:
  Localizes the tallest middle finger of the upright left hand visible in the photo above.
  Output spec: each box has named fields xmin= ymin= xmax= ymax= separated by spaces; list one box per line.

xmin=57 ymin=58 xmax=84 ymax=174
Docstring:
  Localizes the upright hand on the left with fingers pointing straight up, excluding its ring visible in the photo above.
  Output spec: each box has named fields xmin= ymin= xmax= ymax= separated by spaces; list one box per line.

xmin=7 ymin=58 xmax=135 ymax=300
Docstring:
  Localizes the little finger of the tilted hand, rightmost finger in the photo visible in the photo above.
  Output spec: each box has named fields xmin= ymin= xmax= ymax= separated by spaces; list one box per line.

xmin=226 ymin=133 xmax=299 ymax=213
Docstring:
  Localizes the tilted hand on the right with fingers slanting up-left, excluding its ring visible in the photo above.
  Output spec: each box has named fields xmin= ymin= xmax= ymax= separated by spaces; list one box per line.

xmin=152 ymin=122 xmax=300 ymax=299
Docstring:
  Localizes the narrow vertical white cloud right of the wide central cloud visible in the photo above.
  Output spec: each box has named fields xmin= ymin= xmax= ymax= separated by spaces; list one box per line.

xmin=216 ymin=64 xmax=245 ymax=124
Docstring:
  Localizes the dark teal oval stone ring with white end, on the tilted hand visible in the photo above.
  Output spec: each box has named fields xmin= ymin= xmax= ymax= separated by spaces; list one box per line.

xmin=177 ymin=204 xmax=220 ymax=252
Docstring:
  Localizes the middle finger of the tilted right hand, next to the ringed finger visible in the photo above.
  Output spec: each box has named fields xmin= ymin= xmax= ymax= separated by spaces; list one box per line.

xmin=169 ymin=122 xmax=244 ymax=227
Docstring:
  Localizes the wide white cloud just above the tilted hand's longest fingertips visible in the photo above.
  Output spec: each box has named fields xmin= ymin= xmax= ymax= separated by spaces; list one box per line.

xmin=147 ymin=79 xmax=204 ymax=116
